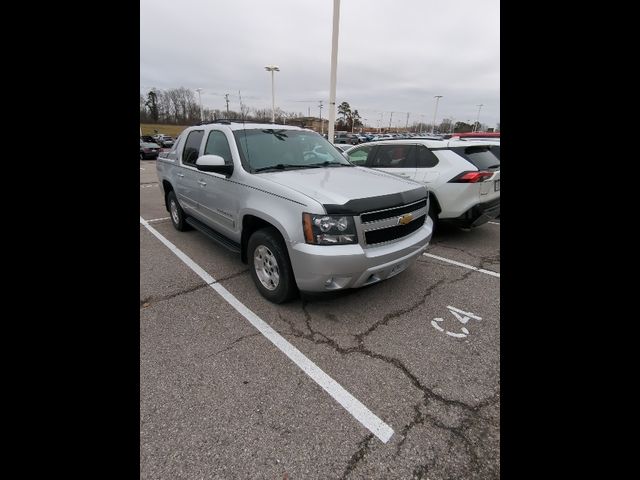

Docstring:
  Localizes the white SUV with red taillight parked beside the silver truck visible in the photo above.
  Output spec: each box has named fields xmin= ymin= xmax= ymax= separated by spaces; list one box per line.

xmin=346 ymin=138 xmax=500 ymax=228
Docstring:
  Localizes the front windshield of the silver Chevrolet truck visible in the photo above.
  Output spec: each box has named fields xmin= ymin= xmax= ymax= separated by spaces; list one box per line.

xmin=233 ymin=128 xmax=352 ymax=172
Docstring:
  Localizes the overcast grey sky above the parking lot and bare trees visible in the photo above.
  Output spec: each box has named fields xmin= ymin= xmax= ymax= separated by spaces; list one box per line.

xmin=140 ymin=0 xmax=500 ymax=127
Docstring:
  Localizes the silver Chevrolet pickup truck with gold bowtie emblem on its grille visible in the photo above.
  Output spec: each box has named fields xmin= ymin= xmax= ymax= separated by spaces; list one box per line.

xmin=156 ymin=120 xmax=433 ymax=303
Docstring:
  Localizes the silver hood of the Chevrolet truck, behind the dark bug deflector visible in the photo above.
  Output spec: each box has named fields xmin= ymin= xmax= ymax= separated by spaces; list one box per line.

xmin=259 ymin=167 xmax=426 ymax=207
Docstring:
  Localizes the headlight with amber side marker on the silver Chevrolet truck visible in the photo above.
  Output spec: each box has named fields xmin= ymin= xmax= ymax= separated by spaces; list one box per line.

xmin=302 ymin=213 xmax=358 ymax=245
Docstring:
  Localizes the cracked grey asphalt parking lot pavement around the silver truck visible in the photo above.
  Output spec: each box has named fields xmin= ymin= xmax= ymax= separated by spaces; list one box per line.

xmin=140 ymin=160 xmax=500 ymax=480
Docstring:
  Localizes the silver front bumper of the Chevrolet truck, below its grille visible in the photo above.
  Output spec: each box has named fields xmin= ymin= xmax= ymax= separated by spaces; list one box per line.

xmin=289 ymin=217 xmax=433 ymax=292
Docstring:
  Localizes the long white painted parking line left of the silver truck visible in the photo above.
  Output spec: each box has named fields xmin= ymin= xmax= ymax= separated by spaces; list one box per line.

xmin=140 ymin=217 xmax=394 ymax=443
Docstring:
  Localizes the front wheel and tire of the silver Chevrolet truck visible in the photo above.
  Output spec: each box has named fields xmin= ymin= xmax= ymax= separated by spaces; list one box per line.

xmin=247 ymin=227 xmax=298 ymax=303
